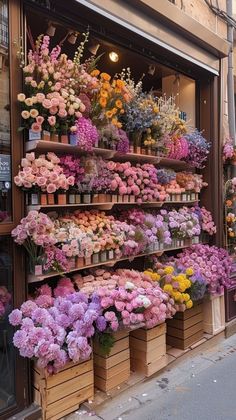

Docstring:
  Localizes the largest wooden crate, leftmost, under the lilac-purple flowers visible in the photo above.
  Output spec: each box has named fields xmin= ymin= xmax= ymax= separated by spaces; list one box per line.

xmin=33 ymin=360 xmax=94 ymax=420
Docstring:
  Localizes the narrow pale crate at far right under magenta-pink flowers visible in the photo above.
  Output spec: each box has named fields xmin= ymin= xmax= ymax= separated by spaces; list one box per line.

xmin=203 ymin=295 xmax=225 ymax=335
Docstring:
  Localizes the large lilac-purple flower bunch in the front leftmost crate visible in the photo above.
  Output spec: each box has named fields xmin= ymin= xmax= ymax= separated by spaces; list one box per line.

xmin=9 ymin=292 xmax=105 ymax=373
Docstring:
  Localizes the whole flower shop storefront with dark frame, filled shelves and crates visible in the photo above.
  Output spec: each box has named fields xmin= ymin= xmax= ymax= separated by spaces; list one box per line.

xmin=0 ymin=0 xmax=232 ymax=419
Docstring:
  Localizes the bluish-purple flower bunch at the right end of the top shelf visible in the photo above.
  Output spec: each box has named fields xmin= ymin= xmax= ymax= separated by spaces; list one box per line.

xmin=185 ymin=130 xmax=210 ymax=169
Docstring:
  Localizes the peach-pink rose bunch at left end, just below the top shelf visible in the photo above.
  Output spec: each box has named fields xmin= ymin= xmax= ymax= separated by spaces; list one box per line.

xmin=14 ymin=152 xmax=75 ymax=194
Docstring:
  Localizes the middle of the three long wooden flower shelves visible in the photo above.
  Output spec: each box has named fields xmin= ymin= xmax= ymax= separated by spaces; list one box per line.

xmin=27 ymin=200 xmax=199 ymax=212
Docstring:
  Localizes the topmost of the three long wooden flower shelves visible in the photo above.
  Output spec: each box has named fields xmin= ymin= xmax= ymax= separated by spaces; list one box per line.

xmin=25 ymin=140 xmax=191 ymax=169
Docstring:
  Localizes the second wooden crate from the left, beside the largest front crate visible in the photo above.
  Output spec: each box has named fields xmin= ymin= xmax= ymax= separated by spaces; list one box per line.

xmin=94 ymin=331 xmax=130 ymax=392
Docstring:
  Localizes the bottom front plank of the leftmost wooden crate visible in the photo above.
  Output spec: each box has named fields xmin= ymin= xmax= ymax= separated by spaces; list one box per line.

xmin=46 ymin=384 xmax=94 ymax=419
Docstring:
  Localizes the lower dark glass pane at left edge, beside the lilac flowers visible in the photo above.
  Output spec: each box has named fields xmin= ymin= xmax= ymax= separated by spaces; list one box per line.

xmin=0 ymin=236 xmax=15 ymax=417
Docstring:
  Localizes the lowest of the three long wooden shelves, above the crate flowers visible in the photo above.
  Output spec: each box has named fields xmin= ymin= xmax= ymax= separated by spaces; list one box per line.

xmin=27 ymin=244 xmax=195 ymax=283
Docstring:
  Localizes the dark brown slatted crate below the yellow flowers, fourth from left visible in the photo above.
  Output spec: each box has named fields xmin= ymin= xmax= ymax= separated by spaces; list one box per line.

xmin=166 ymin=303 xmax=203 ymax=350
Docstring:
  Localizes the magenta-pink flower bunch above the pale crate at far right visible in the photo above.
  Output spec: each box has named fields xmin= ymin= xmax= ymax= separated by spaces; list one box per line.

xmin=177 ymin=244 xmax=232 ymax=295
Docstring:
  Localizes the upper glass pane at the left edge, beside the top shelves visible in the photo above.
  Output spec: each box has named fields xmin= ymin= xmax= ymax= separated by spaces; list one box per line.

xmin=0 ymin=0 xmax=12 ymax=223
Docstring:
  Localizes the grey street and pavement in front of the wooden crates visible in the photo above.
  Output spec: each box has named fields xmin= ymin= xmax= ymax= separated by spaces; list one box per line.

xmin=67 ymin=335 xmax=236 ymax=420
